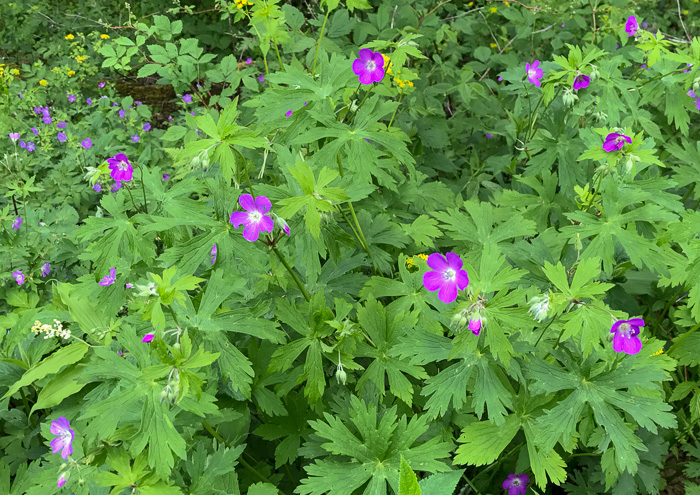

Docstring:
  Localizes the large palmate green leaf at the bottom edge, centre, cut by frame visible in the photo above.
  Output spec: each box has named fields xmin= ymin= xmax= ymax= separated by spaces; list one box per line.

xmin=295 ymin=396 xmax=451 ymax=495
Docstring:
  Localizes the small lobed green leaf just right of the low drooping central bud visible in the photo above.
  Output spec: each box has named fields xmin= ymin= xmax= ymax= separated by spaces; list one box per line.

xmin=355 ymin=297 xmax=428 ymax=406
